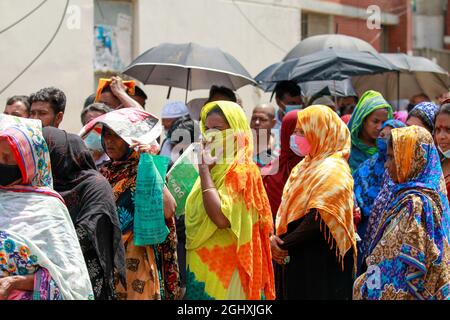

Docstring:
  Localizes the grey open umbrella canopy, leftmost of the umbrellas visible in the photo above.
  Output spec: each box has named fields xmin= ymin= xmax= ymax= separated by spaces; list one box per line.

xmin=123 ymin=43 xmax=256 ymax=90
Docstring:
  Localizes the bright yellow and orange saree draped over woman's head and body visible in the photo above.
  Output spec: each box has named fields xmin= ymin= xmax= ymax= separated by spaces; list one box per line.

xmin=185 ymin=101 xmax=275 ymax=300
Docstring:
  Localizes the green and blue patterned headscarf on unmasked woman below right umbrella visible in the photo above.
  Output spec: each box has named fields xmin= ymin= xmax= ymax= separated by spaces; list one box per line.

xmin=348 ymin=90 xmax=393 ymax=170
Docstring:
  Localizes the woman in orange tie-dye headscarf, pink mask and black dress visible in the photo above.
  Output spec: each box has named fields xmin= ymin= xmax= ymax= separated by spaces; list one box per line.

xmin=271 ymin=105 xmax=356 ymax=299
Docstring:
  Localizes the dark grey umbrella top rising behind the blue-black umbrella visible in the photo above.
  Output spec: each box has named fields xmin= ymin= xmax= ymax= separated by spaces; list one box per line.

xmin=283 ymin=34 xmax=377 ymax=61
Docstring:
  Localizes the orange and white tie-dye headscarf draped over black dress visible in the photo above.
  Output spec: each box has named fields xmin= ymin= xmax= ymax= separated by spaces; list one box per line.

xmin=276 ymin=105 xmax=356 ymax=263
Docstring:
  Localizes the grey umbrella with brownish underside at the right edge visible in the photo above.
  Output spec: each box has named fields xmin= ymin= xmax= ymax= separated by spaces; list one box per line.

xmin=352 ymin=53 xmax=450 ymax=100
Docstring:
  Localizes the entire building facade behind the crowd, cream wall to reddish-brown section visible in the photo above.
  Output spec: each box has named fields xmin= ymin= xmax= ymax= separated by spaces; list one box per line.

xmin=0 ymin=0 xmax=442 ymax=132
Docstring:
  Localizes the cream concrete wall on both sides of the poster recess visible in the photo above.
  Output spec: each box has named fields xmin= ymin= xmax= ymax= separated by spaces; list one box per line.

xmin=0 ymin=0 xmax=301 ymax=132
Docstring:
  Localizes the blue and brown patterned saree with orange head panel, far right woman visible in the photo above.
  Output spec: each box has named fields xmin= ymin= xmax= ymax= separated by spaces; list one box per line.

xmin=353 ymin=126 xmax=450 ymax=300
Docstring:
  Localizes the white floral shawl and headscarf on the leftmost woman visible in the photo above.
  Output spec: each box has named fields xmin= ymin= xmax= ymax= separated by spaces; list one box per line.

xmin=0 ymin=116 xmax=93 ymax=300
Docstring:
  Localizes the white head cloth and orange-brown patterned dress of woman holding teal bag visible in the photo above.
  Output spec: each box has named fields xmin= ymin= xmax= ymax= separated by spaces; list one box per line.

xmin=95 ymin=108 xmax=180 ymax=300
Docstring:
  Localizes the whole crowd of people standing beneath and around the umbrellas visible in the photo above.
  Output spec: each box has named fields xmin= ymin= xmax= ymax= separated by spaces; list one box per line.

xmin=0 ymin=77 xmax=450 ymax=300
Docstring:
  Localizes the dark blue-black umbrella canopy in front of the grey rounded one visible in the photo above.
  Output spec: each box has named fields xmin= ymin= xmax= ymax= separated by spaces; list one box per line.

xmin=255 ymin=49 xmax=398 ymax=84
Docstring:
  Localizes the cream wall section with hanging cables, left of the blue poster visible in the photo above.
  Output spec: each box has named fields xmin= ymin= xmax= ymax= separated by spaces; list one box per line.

xmin=0 ymin=0 xmax=94 ymax=132
